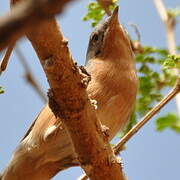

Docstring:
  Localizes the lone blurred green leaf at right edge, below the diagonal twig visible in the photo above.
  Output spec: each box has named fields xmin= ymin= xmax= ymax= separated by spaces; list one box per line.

xmin=156 ymin=113 xmax=180 ymax=133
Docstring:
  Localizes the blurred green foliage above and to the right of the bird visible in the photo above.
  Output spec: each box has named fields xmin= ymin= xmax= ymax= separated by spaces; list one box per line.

xmin=83 ymin=1 xmax=180 ymax=135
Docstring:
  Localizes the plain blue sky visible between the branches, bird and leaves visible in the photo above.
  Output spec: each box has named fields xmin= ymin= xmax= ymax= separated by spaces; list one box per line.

xmin=0 ymin=0 xmax=180 ymax=180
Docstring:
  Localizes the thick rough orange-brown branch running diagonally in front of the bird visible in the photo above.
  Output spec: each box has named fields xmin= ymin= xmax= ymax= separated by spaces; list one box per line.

xmin=1 ymin=1 xmax=124 ymax=180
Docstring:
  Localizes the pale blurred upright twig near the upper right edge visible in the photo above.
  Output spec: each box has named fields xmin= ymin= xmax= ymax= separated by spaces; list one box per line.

xmin=154 ymin=0 xmax=180 ymax=114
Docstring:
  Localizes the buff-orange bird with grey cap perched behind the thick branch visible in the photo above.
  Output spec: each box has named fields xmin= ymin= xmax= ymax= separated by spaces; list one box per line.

xmin=1 ymin=8 xmax=138 ymax=180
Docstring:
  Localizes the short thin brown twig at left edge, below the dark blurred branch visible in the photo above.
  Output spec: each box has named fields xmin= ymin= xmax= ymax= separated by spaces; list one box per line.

xmin=0 ymin=43 xmax=15 ymax=75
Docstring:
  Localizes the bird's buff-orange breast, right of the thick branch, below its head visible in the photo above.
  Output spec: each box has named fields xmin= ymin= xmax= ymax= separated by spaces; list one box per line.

xmin=87 ymin=61 xmax=138 ymax=138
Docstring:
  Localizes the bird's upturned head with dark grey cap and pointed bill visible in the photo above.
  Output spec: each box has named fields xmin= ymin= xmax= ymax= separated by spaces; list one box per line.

xmin=86 ymin=7 xmax=133 ymax=62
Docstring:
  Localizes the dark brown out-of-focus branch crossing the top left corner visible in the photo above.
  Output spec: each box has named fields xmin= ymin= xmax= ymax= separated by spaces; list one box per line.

xmin=0 ymin=0 xmax=75 ymax=50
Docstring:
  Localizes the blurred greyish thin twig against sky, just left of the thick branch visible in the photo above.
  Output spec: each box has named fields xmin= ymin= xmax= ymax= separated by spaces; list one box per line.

xmin=15 ymin=46 xmax=47 ymax=102
